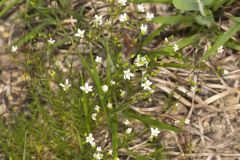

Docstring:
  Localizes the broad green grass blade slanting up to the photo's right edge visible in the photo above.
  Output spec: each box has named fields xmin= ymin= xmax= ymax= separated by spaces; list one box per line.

xmin=200 ymin=23 xmax=240 ymax=61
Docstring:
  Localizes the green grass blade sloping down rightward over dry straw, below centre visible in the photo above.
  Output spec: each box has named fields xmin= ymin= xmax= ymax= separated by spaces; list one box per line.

xmin=123 ymin=110 xmax=181 ymax=132
